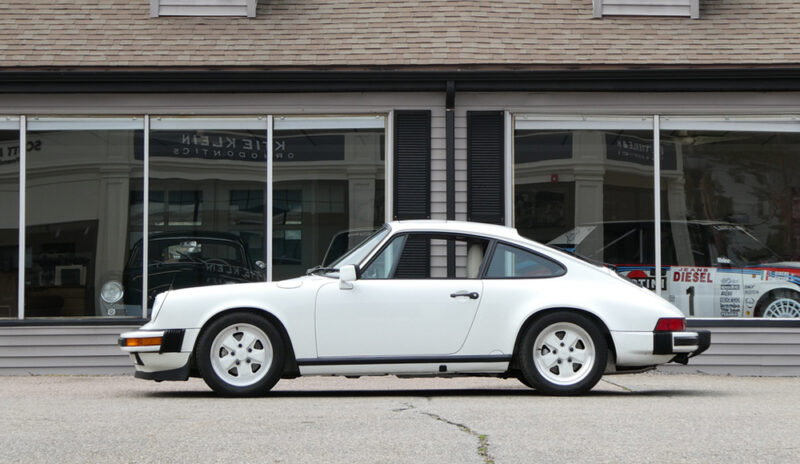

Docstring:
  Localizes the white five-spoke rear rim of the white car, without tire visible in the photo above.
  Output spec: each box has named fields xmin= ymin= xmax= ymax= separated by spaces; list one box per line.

xmin=533 ymin=322 xmax=596 ymax=385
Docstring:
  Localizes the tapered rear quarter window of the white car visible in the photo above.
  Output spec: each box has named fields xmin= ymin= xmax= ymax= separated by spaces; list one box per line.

xmin=486 ymin=243 xmax=566 ymax=279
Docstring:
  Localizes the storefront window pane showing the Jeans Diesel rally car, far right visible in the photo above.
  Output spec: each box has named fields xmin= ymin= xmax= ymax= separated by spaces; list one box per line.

xmin=661 ymin=124 xmax=800 ymax=318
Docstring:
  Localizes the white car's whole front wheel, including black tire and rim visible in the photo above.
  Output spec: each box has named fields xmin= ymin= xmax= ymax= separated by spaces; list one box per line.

xmin=195 ymin=312 xmax=286 ymax=396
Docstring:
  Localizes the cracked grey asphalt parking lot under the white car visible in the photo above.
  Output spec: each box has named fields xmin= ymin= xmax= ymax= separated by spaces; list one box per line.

xmin=0 ymin=373 xmax=800 ymax=464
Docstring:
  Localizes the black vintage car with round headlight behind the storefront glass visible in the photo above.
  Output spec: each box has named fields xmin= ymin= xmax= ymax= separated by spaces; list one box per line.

xmin=100 ymin=231 xmax=265 ymax=316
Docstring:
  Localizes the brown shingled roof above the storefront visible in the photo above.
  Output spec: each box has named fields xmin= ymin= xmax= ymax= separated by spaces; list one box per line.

xmin=0 ymin=0 xmax=800 ymax=70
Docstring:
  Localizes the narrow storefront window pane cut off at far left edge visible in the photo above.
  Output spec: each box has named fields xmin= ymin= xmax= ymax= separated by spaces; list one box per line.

xmin=0 ymin=128 xmax=20 ymax=318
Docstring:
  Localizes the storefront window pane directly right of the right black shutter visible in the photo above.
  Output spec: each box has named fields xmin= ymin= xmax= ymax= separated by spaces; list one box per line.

xmin=514 ymin=121 xmax=654 ymax=267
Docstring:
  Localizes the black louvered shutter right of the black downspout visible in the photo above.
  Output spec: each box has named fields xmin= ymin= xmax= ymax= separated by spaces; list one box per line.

xmin=467 ymin=111 xmax=505 ymax=224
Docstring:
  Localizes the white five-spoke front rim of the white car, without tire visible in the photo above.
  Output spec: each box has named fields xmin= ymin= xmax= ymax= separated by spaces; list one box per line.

xmin=208 ymin=323 xmax=274 ymax=387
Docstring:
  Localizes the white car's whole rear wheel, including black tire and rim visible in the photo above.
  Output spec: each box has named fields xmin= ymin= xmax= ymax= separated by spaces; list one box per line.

xmin=517 ymin=311 xmax=608 ymax=395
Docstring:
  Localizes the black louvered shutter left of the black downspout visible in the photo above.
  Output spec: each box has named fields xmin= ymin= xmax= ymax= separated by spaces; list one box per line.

xmin=394 ymin=111 xmax=431 ymax=220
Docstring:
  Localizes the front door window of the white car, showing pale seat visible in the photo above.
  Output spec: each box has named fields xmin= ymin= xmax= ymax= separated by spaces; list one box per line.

xmin=361 ymin=233 xmax=489 ymax=279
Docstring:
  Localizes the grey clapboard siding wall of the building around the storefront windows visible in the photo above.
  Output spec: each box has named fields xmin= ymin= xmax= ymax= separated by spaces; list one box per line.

xmin=0 ymin=92 xmax=800 ymax=375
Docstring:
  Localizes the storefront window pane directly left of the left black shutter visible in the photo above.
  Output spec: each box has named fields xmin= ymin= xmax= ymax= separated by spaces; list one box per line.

xmin=272 ymin=118 xmax=385 ymax=280
